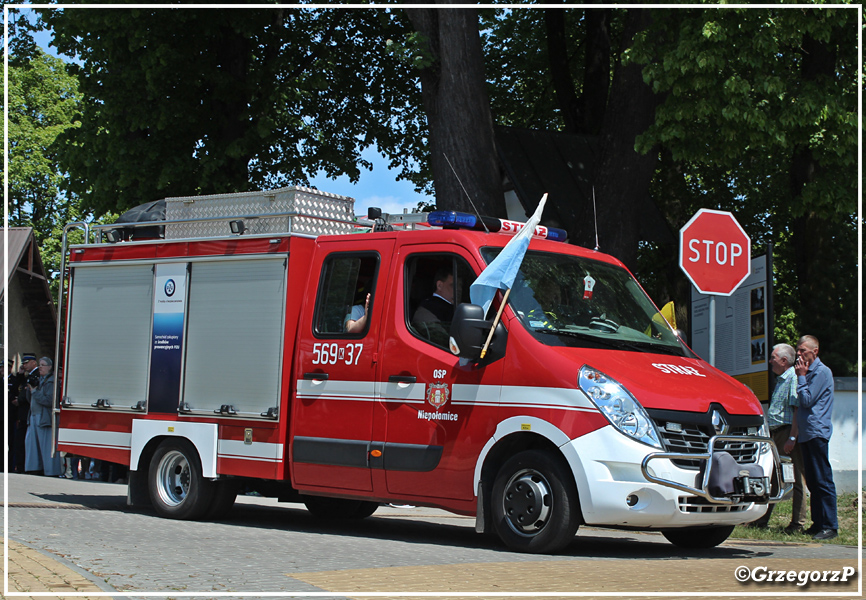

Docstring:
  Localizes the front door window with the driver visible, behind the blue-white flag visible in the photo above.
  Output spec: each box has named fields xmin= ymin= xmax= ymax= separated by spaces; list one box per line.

xmin=405 ymin=254 xmax=476 ymax=349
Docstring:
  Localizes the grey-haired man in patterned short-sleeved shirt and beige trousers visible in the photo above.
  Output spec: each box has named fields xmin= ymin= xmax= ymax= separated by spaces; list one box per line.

xmin=750 ymin=344 xmax=806 ymax=533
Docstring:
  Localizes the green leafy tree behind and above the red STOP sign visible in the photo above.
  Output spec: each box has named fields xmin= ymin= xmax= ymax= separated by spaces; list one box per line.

xmin=629 ymin=7 xmax=859 ymax=374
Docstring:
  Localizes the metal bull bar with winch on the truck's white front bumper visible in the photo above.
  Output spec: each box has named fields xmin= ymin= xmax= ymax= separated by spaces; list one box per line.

xmin=640 ymin=435 xmax=794 ymax=504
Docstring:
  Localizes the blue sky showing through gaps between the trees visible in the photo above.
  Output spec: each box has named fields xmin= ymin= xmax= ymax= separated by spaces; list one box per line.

xmin=27 ymin=12 xmax=431 ymax=215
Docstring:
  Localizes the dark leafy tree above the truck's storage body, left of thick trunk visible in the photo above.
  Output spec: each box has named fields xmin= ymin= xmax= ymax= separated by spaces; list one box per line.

xmin=42 ymin=6 xmax=424 ymax=216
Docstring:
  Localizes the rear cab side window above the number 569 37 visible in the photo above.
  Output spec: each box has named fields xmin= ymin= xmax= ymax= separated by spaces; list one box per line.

xmin=315 ymin=253 xmax=379 ymax=337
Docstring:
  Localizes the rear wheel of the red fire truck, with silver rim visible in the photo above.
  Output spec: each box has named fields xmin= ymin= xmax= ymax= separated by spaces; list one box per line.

xmin=148 ymin=438 xmax=215 ymax=520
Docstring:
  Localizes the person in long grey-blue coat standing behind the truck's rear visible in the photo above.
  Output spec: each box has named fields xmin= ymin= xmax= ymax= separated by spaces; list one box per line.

xmin=25 ymin=356 xmax=62 ymax=477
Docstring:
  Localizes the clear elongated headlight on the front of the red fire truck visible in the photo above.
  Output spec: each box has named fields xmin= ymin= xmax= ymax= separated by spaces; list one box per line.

xmin=577 ymin=365 xmax=663 ymax=450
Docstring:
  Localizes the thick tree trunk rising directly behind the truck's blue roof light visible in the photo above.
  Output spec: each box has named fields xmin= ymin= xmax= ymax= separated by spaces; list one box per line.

xmin=406 ymin=2 xmax=506 ymax=217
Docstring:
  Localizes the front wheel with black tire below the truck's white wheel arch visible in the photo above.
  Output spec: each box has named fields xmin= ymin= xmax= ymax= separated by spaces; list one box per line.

xmin=490 ymin=450 xmax=580 ymax=554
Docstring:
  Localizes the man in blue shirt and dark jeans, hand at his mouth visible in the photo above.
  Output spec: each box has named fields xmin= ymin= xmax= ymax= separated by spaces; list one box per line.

xmin=785 ymin=335 xmax=839 ymax=540
